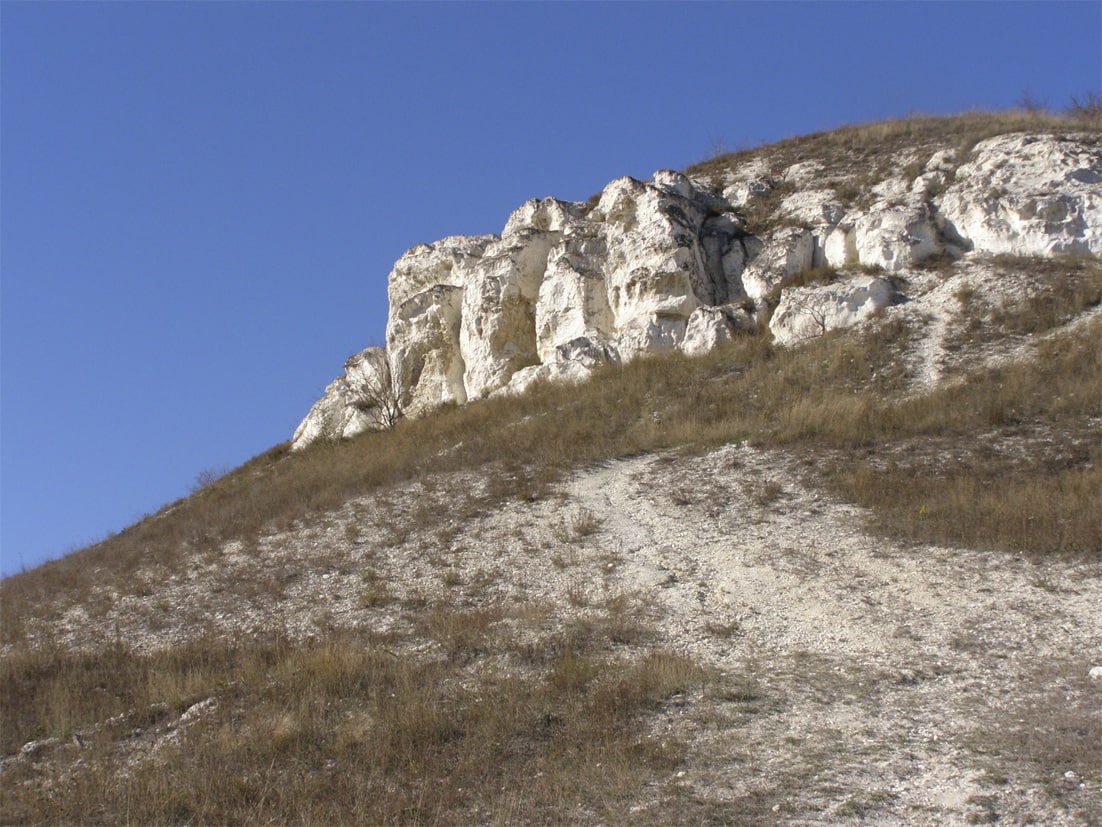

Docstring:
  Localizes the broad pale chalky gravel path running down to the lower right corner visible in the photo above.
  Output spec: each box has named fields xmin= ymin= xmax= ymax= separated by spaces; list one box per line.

xmin=559 ymin=448 xmax=1102 ymax=825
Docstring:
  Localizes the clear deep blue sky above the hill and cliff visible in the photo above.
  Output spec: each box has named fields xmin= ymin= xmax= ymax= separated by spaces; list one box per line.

xmin=0 ymin=0 xmax=1102 ymax=573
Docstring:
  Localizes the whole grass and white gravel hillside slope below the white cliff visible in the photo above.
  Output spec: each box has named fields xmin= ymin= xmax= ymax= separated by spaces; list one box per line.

xmin=0 ymin=118 xmax=1102 ymax=825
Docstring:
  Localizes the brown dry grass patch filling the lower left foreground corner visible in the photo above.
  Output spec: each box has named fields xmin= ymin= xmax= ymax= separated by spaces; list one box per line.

xmin=0 ymin=606 xmax=705 ymax=824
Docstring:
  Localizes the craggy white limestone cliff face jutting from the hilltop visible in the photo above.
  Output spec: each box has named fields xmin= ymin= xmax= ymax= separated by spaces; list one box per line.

xmin=293 ymin=133 xmax=1102 ymax=449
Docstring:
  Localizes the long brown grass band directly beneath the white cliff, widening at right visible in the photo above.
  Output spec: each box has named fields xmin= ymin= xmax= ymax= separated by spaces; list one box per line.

xmin=0 ymin=257 xmax=1102 ymax=630
